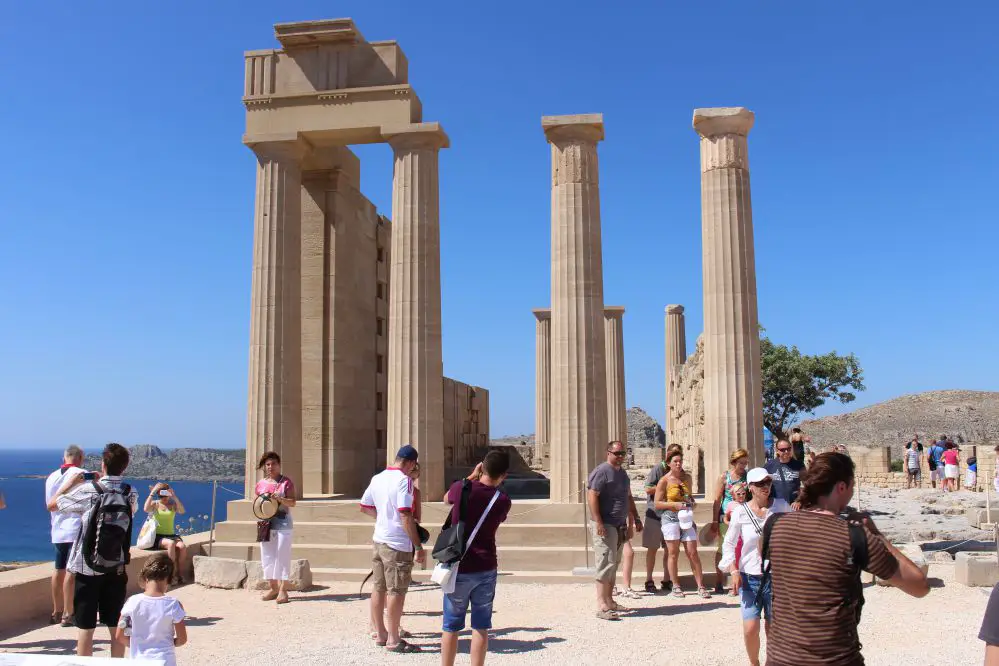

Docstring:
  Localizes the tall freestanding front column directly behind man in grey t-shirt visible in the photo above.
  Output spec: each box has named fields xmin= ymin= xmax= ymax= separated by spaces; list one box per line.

xmin=541 ymin=114 xmax=607 ymax=502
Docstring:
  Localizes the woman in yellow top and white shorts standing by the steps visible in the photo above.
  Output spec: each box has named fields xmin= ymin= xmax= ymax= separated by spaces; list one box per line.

xmin=655 ymin=451 xmax=711 ymax=599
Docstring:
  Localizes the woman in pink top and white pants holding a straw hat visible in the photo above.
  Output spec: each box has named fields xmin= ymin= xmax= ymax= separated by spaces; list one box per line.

xmin=256 ymin=451 xmax=295 ymax=604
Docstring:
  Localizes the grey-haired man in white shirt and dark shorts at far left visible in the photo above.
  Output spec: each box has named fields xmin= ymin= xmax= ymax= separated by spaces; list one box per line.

xmin=45 ymin=444 xmax=83 ymax=627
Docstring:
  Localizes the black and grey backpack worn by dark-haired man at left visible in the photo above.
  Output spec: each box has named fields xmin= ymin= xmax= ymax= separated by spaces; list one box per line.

xmin=80 ymin=481 xmax=132 ymax=574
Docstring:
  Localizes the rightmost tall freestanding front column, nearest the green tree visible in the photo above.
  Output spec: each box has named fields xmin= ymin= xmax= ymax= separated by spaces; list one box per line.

xmin=694 ymin=107 xmax=763 ymax=485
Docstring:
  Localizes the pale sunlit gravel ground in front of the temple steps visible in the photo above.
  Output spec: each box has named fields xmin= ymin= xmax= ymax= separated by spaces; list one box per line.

xmin=0 ymin=564 xmax=989 ymax=666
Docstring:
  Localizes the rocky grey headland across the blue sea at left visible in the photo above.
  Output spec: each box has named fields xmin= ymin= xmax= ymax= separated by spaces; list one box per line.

xmin=84 ymin=444 xmax=246 ymax=482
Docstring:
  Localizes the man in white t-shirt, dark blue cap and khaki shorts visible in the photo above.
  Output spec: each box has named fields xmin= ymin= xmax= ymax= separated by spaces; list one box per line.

xmin=361 ymin=444 xmax=427 ymax=653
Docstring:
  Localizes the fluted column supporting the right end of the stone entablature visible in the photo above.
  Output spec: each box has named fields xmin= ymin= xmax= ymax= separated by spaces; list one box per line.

xmin=382 ymin=123 xmax=448 ymax=502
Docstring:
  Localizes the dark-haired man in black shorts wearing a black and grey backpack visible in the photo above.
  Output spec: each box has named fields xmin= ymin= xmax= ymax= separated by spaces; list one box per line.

xmin=49 ymin=443 xmax=138 ymax=657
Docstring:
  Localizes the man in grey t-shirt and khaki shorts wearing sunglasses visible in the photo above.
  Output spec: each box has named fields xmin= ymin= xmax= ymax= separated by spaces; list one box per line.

xmin=586 ymin=441 xmax=642 ymax=620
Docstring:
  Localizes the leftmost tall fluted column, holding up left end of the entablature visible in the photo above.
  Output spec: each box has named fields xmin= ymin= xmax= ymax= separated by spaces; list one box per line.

xmin=246 ymin=141 xmax=302 ymax=497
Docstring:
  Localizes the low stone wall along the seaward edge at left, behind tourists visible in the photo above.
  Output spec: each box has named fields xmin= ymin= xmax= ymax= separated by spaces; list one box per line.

xmin=0 ymin=532 xmax=209 ymax=637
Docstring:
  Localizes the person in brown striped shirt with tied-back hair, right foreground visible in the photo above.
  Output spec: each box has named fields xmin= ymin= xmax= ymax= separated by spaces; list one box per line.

xmin=760 ymin=452 xmax=929 ymax=666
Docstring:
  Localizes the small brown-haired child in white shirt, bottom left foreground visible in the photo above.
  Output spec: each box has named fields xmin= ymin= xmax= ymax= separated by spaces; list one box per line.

xmin=117 ymin=553 xmax=187 ymax=666
